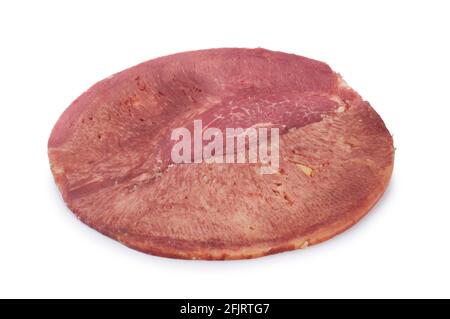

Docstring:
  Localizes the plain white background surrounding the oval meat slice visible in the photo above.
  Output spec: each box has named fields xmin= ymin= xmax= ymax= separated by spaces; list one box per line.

xmin=0 ymin=0 xmax=450 ymax=298
